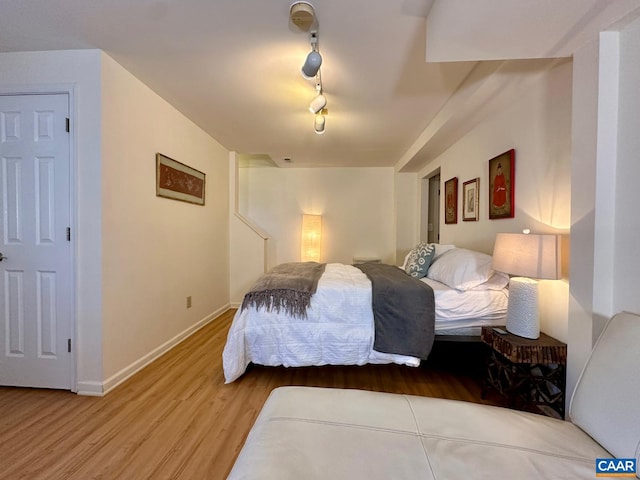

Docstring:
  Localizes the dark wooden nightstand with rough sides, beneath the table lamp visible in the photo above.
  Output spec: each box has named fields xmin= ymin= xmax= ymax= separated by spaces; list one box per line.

xmin=481 ymin=327 xmax=567 ymax=418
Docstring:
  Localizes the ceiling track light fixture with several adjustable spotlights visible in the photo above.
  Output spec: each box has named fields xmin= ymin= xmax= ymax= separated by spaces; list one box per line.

xmin=289 ymin=2 xmax=327 ymax=135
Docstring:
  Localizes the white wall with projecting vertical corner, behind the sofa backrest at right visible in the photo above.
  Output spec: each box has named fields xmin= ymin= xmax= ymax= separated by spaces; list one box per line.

xmin=567 ymin=13 xmax=640 ymax=404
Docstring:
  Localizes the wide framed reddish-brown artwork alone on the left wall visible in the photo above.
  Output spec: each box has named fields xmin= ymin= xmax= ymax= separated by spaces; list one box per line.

xmin=156 ymin=153 xmax=205 ymax=205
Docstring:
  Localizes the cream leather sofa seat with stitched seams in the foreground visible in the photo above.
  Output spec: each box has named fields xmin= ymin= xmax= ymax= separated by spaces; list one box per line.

xmin=228 ymin=387 xmax=610 ymax=480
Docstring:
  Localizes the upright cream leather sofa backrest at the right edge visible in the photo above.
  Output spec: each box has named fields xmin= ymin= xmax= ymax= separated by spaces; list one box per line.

xmin=569 ymin=312 xmax=640 ymax=465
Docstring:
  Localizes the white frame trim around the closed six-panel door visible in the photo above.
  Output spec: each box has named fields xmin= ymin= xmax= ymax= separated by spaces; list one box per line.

xmin=0 ymin=83 xmax=79 ymax=393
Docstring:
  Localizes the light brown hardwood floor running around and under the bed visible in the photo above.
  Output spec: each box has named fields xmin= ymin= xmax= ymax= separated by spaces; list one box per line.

xmin=0 ymin=310 xmax=510 ymax=480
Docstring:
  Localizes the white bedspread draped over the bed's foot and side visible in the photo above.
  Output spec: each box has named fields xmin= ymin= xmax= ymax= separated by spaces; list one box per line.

xmin=222 ymin=263 xmax=420 ymax=383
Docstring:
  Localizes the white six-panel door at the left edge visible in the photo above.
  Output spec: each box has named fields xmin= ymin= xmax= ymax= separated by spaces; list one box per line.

xmin=0 ymin=94 xmax=73 ymax=389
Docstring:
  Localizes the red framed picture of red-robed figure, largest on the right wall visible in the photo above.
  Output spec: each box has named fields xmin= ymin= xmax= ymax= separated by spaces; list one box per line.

xmin=489 ymin=149 xmax=516 ymax=219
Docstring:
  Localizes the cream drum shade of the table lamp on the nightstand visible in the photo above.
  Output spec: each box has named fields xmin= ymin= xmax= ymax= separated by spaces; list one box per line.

xmin=493 ymin=233 xmax=561 ymax=280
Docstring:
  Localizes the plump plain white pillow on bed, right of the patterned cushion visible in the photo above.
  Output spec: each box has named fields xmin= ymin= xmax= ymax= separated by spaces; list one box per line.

xmin=427 ymin=248 xmax=495 ymax=290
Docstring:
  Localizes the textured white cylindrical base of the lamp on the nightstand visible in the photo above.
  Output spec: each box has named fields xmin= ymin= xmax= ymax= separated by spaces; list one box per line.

xmin=506 ymin=277 xmax=540 ymax=339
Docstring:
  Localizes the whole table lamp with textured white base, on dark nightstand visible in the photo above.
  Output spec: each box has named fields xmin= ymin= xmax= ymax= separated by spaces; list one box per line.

xmin=493 ymin=233 xmax=560 ymax=339
